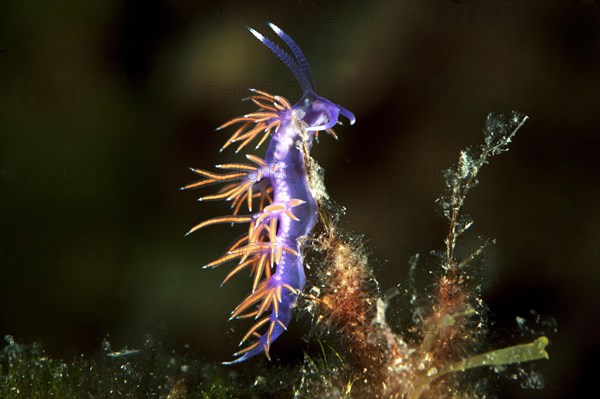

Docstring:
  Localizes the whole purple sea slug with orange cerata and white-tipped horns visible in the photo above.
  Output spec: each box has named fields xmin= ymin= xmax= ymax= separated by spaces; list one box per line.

xmin=182 ymin=23 xmax=355 ymax=364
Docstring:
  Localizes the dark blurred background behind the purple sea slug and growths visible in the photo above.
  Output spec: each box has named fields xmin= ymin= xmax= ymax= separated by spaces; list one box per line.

xmin=0 ymin=0 xmax=600 ymax=398
